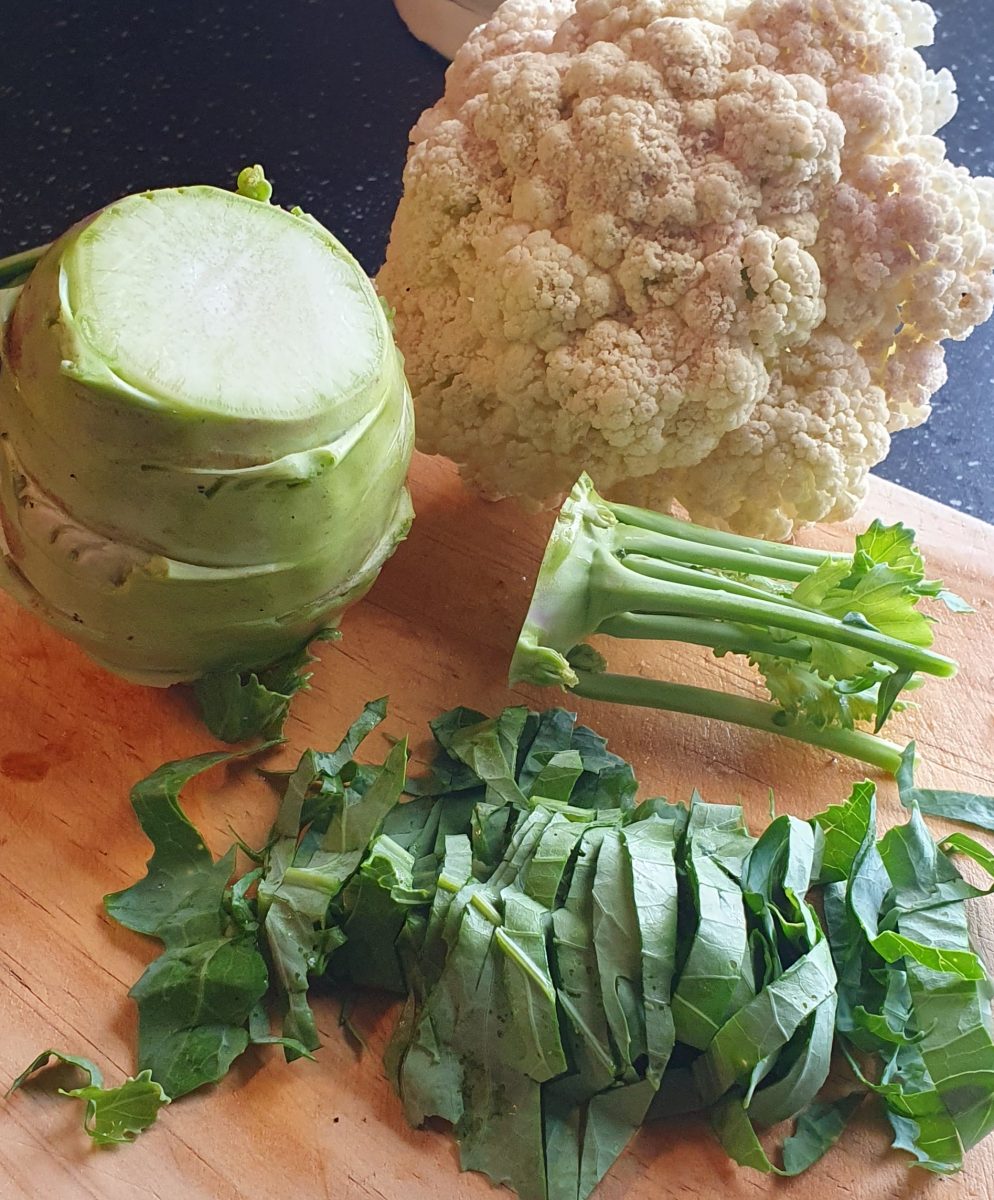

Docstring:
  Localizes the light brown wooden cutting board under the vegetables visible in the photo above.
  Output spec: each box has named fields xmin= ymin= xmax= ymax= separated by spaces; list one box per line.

xmin=0 ymin=457 xmax=994 ymax=1200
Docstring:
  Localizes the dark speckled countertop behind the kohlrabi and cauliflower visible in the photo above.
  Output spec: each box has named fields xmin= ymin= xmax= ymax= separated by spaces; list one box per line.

xmin=0 ymin=0 xmax=994 ymax=522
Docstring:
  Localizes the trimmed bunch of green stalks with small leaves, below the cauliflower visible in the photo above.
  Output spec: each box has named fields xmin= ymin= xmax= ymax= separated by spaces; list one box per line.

xmin=510 ymin=475 xmax=971 ymax=774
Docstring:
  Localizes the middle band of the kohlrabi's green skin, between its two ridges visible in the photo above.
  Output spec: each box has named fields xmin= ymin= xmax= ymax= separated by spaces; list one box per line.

xmin=0 ymin=350 xmax=414 ymax=566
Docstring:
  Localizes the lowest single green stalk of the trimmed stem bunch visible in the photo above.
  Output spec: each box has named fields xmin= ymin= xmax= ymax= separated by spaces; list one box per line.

xmin=570 ymin=671 xmax=902 ymax=775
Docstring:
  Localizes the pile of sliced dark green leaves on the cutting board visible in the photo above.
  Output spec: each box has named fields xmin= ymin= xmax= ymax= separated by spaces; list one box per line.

xmin=18 ymin=700 xmax=994 ymax=1200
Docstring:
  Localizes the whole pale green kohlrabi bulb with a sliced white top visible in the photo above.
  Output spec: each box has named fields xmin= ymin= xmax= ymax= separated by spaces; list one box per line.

xmin=0 ymin=187 xmax=413 ymax=685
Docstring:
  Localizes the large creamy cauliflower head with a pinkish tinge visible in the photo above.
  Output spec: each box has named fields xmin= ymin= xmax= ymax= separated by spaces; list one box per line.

xmin=378 ymin=0 xmax=994 ymax=538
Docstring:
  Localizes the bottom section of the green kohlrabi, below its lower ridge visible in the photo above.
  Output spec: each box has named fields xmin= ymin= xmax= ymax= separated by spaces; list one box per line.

xmin=0 ymin=445 xmax=413 ymax=686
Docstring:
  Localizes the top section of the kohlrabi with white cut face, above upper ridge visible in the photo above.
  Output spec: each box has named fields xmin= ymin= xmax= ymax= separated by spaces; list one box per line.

xmin=4 ymin=187 xmax=393 ymax=469
